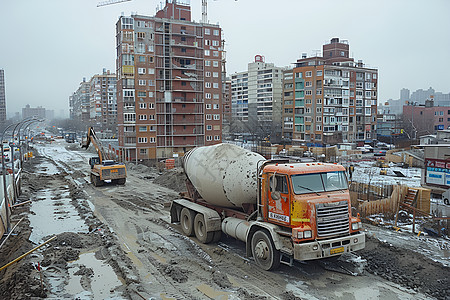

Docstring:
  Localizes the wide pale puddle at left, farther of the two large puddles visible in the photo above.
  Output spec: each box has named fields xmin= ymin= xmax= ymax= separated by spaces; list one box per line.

xmin=29 ymin=186 xmax=88 ymax=244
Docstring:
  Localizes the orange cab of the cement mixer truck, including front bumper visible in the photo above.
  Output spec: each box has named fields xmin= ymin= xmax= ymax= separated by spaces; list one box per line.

xmin=259 ymin=163 xmax=365 ymax=260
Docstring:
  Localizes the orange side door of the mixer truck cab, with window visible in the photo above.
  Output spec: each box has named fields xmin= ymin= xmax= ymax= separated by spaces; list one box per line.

xmin=267 ymin=174 xmax=291 ymax=225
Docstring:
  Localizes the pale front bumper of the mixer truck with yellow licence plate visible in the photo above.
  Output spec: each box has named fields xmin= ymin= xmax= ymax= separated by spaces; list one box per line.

xmin=294 ymin=233 xmax=366 ymax=260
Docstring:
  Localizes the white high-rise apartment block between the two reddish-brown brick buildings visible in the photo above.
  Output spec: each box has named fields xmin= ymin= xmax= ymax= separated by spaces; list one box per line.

xmin=231 ymin=55 xmax=283 ymax=140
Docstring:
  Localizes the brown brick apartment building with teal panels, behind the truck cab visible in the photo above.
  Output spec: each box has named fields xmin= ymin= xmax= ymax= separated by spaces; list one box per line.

xmin=283 ymin=38 xmax=378 ymax=145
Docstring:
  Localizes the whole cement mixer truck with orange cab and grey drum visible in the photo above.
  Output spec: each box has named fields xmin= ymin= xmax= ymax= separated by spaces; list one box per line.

xmin=170 ymin=144 xmax=365 ymax=270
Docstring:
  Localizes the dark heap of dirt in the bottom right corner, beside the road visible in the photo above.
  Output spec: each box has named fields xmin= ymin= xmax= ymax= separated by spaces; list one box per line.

xmin=358 ymin=236 xmax=450 ymax=300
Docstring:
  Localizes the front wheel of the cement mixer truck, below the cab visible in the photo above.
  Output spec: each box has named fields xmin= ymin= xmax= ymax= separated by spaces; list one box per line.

xmin=252 ymin=230 xmax=280 ymax=271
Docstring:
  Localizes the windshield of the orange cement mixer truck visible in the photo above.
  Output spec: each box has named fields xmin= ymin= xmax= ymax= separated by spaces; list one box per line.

xmin=292 ymin=171 xmax=348 ymax=194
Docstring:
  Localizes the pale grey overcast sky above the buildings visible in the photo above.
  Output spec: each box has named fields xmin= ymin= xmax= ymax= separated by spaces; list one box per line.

xmin=0 ymin=0 xmax=450 ymax=116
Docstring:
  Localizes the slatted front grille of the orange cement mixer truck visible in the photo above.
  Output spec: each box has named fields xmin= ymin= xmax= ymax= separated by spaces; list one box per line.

xmin=316 ymin=201 xmax=350 ymax=237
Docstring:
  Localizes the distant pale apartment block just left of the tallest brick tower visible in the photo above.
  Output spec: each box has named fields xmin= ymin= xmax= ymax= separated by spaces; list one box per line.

xmin=89 ymin=69 xmax=117 ymax=132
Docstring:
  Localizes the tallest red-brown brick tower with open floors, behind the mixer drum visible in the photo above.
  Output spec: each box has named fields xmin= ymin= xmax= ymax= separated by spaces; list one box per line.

xmin=116 ymin=0 xmax=224 ymax=160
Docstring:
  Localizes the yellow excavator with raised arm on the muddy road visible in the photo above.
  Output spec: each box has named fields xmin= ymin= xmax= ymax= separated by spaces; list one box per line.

xmin=81 ymin=127 xmax=127 ymax=186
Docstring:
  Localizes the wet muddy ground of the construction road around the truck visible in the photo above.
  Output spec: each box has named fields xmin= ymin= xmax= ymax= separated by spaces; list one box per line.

xmin=0 ymin=142 xmax=450 ymax=299
